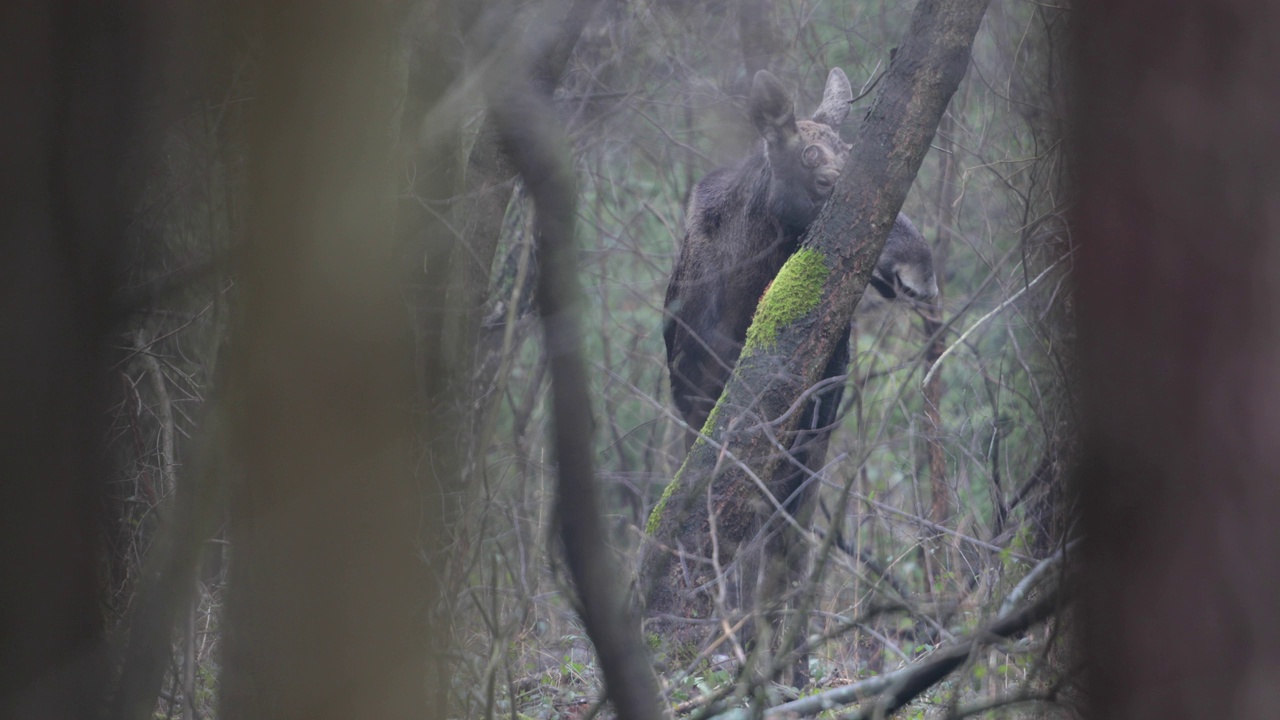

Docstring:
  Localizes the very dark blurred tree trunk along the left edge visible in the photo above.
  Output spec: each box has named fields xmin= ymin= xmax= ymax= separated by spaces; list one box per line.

xmin=0 ymin=0 xmax=152 ymax=719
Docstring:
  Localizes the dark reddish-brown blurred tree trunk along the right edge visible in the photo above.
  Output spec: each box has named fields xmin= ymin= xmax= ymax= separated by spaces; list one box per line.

xmin=1076 ymin=0 xmax=1280 ymax=720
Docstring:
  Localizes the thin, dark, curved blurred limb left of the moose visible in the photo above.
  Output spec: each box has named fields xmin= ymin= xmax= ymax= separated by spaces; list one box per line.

xmin=490 ymin=46 xmax=664 ymax=720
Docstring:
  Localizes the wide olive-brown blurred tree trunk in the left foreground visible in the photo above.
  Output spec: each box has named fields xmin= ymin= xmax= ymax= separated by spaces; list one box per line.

xmin=220 ymin=1 xmax=437 ymax=719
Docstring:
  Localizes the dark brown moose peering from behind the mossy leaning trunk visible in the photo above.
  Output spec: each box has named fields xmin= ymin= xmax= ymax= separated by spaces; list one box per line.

xmin=663 ymin=68 xmax=937 ymax=678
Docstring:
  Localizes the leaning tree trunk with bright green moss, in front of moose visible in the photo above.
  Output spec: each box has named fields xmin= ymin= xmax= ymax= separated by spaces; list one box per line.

xmin=641 ymin=0 xmax=987 ymax=637
